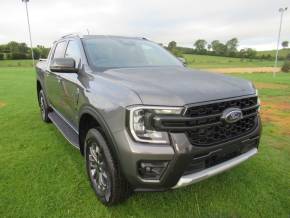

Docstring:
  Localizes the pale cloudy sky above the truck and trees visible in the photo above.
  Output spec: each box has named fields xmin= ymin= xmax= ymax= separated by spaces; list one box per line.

xmin=0 ymin=0 xmax=290 ymax=50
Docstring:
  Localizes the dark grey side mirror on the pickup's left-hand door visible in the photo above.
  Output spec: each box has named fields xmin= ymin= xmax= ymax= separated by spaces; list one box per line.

xmin=50 ymin=58 xmax=78 ymax=73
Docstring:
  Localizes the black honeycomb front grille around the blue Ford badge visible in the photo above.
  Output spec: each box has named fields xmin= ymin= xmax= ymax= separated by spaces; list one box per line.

xmin=185 ymin=97 xmax=258 ymax=147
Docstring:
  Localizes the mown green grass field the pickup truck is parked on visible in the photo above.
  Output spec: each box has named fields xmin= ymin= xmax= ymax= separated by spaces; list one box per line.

xmin=0 ymin=63 xmax=290 ymax=218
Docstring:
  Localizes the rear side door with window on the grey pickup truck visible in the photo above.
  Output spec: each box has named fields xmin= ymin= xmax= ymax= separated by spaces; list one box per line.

xmin=44 ymin=41 xmax=67 ymax=110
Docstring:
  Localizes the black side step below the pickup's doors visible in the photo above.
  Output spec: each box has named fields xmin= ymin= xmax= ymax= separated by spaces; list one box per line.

xmin=48 ymin=111 xmax=79 ymax=149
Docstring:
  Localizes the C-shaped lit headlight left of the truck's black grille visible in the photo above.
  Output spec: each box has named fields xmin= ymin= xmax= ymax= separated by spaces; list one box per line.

xmin=128 ymin=106 xmax=183 ymax=144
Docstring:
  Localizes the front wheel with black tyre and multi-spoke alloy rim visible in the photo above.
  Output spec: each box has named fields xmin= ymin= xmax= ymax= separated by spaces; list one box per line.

xmin=85 ymin=129 xmax=129 ymax=206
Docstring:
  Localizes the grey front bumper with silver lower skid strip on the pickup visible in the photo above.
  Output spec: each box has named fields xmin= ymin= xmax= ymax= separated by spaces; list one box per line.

xmin=114 ymin=116 xmax=261 ymax=191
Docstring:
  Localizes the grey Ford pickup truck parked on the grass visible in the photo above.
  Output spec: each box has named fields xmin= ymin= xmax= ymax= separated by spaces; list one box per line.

xmin=36 ymin=35 xmax=261 ymax=205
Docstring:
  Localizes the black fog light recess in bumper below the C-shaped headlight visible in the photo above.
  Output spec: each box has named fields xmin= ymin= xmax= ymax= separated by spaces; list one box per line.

xmin=138 ymin=161 xmax=168 ymax=180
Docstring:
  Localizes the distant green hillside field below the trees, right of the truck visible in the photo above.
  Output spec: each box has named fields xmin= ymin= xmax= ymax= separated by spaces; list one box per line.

xmin=183 ymin=54 xmax=282 ymax=69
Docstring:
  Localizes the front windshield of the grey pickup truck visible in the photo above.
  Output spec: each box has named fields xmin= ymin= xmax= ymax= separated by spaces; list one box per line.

xmin=83 ymin=37 xmax=182 ymax=69
